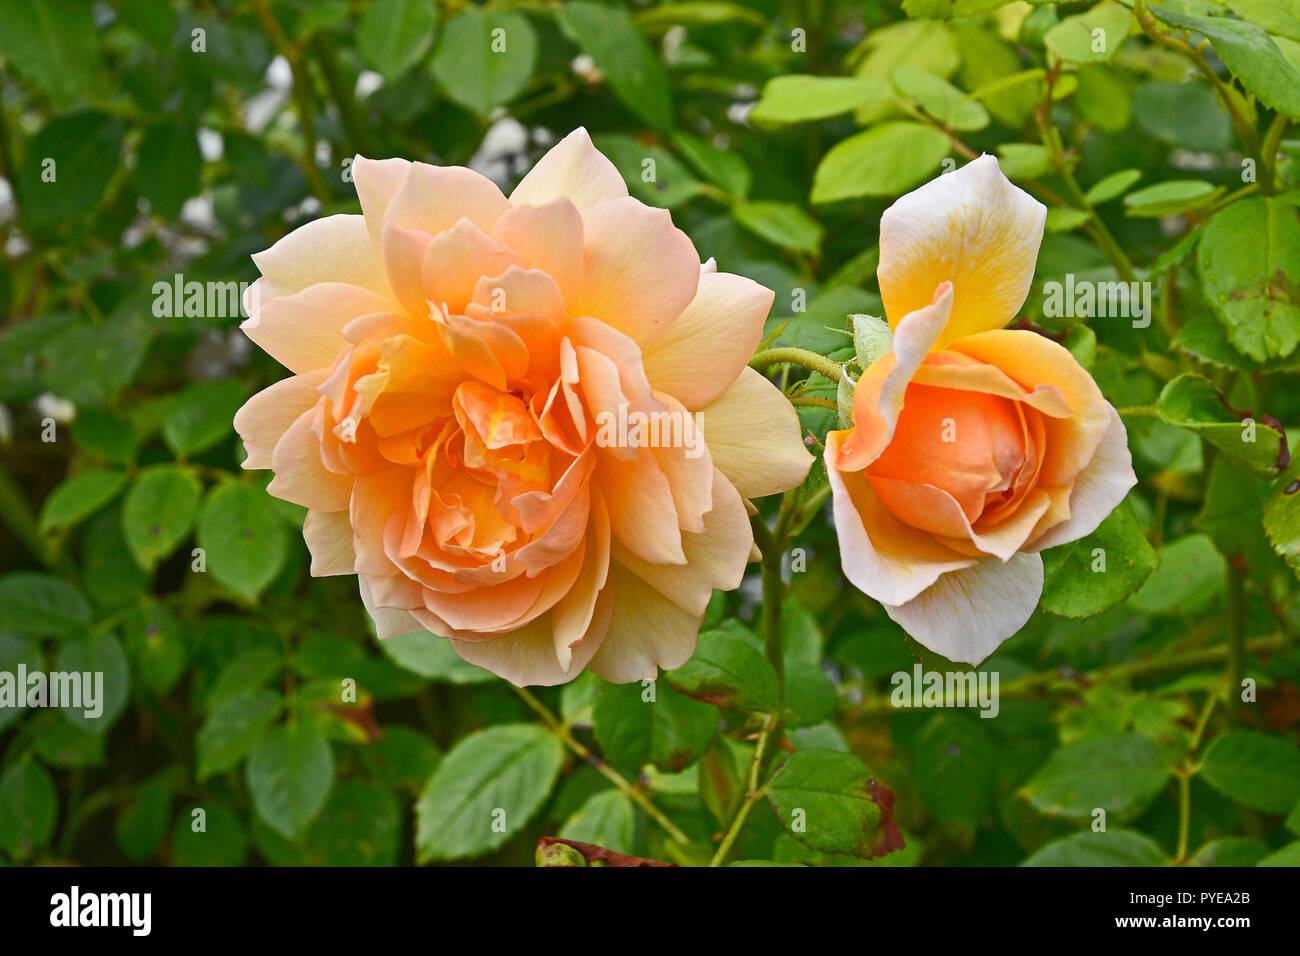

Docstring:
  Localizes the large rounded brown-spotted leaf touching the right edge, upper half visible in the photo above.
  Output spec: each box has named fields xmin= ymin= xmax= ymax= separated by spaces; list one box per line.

xmin=1197 ymin=198 xmax=1300 ymax=362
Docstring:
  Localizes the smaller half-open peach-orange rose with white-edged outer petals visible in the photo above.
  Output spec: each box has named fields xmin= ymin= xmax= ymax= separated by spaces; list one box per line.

xmin=826 ymin=156 xmax=1136 ymax=663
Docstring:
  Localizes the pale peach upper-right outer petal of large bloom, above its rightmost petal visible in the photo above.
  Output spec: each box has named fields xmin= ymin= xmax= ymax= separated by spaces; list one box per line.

xmin=645 ymin=272 xmax=776 ymax=410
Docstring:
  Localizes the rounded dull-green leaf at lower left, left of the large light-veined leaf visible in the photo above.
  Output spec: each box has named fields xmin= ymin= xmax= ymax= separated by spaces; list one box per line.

xmin=244 ymin=724 xmax=334 ymax=840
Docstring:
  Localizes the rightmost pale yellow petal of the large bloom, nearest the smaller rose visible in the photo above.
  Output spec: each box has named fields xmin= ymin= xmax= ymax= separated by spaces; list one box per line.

xmin=699 ymin=367 xmax=814 ymax=498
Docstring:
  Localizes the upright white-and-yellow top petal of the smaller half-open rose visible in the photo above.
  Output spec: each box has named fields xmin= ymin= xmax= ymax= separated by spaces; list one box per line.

xmin=876 ymin=155 xmax=1047 ymax=347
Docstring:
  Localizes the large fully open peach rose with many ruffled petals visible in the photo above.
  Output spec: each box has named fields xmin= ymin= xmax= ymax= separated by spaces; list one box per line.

xmin=228 ymin=129 xmax=811 ymax=684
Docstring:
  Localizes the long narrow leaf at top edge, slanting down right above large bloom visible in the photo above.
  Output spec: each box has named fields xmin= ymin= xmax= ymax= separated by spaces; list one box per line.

xmin=560 ymin=0 xmax=672 ymax=129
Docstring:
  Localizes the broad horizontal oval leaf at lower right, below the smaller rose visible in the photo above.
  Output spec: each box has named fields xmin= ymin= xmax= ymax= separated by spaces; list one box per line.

xmin=1021 ymin=734 xmax=1170 ymax=819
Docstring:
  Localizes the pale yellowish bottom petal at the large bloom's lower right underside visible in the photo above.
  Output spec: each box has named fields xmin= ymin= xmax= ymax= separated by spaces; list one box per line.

xmin=589 ymin=562 xmax=701 ymax=684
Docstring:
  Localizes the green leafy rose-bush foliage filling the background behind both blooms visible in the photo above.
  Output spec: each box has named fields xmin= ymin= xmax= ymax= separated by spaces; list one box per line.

xmin=0 ymin=0 xmax=1300 ymax=865
